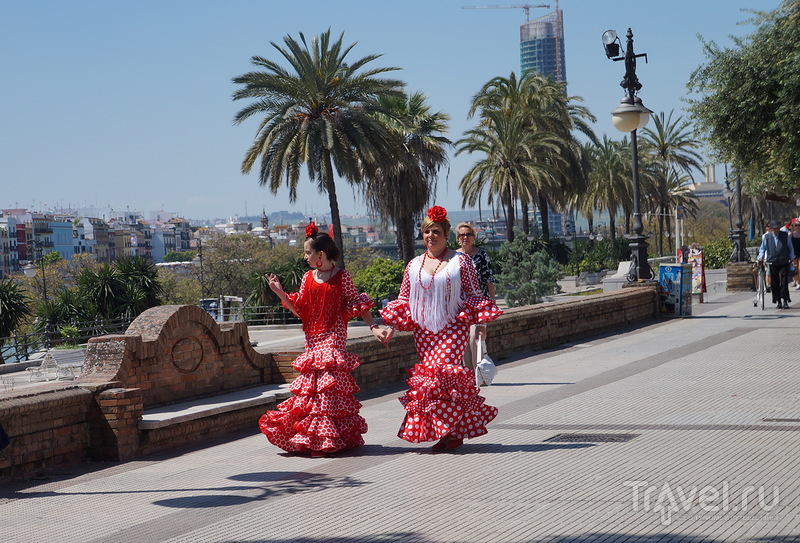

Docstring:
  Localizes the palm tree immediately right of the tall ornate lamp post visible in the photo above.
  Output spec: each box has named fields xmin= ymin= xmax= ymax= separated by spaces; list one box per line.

xmin=642 ymin=111 xmax=702 ymax=254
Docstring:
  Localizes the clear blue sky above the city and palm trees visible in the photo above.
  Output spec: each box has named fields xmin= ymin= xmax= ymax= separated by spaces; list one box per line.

xmin=0 ymin=0 xmax=779 ymax=219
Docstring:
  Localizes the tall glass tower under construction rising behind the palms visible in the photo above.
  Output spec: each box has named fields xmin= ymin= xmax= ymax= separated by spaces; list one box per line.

xmin=519 ymin=0 xmax=567 ymax=81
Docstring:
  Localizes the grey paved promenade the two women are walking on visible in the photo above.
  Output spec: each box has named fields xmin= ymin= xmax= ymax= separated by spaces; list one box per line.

xmin=0 ymin=294 xmax=800 ymax=543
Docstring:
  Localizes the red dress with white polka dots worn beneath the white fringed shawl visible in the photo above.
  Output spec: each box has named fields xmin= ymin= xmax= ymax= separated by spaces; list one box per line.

xmin=381 ymin=253 xmax=502 ymax=443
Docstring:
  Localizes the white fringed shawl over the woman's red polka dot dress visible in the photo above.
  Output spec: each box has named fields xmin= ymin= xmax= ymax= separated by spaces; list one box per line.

xmin=408 ymin=253 xmax=461 ymax=333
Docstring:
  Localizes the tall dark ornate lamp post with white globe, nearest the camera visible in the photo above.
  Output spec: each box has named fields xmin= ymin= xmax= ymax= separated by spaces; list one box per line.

xmin=602 ymin=28 xmax=653 ymax=281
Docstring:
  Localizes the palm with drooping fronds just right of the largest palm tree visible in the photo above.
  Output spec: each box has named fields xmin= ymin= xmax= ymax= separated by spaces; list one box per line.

xmin=364 ymin=92 xmax=451 ymax=262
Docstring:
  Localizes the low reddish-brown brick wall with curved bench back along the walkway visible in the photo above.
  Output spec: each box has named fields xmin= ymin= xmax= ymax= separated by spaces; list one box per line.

xmin=0 ymin=284 xmax=658 ymax=479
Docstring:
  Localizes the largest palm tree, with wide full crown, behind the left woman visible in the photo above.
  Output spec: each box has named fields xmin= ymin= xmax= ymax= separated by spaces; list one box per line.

xmin=233 ymin=29 xmax=404 ymax=265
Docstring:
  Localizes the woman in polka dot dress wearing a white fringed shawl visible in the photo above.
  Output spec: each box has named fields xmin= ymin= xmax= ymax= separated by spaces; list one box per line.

xmin=381 ymin=206 xmax=502 ymax=451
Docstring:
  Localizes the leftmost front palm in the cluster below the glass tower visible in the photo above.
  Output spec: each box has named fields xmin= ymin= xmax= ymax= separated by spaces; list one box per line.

xmin=456 ymin=111 xmax=560 ymax=241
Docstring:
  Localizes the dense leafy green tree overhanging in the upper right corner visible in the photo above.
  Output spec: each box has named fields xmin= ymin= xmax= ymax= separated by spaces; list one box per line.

xmin=687 ymin=0 xmax=800 ymax=200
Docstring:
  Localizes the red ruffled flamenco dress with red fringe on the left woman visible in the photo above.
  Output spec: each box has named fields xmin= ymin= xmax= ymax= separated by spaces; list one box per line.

xmin=258 ymin=270 xmax=374 ymax=453
